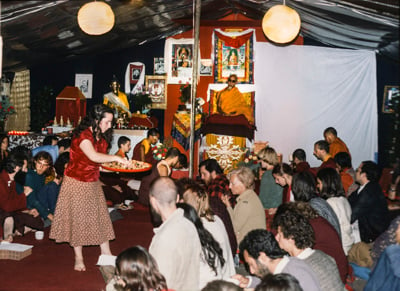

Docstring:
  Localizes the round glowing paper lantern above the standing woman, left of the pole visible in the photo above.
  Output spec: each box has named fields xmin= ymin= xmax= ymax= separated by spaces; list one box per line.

xmin=78 ymin=1 xmax=115 ymax=35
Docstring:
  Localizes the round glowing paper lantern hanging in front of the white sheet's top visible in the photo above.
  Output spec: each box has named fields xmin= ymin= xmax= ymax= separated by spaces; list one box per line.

xmin=262 ymin=5 xmax=301 ymax=44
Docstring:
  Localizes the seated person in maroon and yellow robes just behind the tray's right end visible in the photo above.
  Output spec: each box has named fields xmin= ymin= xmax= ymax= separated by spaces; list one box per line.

xmin=132 ymin=128 xmax=160 ymax=165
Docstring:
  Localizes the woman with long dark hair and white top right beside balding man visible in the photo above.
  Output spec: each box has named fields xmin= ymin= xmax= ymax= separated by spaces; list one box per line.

xmin=176 ymin=203 xmax=225 ymax=289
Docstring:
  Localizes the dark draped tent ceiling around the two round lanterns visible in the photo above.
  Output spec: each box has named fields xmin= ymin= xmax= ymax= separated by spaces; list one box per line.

xmin=0 ymin=0 xmax=399 ymax=71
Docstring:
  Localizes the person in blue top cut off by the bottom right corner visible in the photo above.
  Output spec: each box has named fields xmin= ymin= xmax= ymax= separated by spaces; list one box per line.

xmin=364 ymin=225 xmax=400 ymax=291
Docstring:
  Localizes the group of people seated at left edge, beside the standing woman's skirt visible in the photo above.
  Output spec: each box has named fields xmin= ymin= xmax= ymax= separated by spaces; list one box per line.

xmin=0 ymin=135 xmax=71 ymax=242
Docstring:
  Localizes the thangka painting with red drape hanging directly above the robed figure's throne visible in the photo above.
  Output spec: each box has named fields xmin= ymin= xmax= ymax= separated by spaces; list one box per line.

xmin=213 ymin=29 xmax=255 ymax=84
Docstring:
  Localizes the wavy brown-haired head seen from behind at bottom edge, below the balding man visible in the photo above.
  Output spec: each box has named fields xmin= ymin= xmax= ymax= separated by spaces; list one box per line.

xmin=106 ymin=246 xmax=167 ymax=291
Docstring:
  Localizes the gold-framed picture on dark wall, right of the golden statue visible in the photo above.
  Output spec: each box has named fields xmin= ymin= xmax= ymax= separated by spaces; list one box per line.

xmin=146 ymin=76 xmax=167 ymax=109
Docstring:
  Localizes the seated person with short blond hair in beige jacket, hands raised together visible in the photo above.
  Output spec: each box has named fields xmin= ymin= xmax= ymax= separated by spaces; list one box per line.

xmin=222 ymin=167 xmax=266 ymax=243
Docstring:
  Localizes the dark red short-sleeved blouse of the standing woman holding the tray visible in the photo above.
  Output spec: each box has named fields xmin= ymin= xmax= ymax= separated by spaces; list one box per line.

xmin=65 ymin=128 xmax=108 ymax=182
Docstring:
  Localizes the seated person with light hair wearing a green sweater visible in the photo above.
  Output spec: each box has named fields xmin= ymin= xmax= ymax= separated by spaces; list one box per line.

xmin=257 ymin=147 xmax=283 ymax=216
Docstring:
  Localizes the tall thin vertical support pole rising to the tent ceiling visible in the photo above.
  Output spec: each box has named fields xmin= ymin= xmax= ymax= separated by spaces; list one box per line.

xmin=189 ymin=0 xmax=201 ymax=178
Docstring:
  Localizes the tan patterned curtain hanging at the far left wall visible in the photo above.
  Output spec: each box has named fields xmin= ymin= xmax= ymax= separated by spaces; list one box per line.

xmin=5 ymin=70 xmax=31 ymax=131
